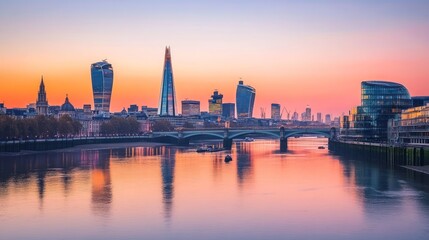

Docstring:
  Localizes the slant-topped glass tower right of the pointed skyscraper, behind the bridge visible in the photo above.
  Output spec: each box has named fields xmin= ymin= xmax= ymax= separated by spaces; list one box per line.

xmin=235 ymin=79 xmax=256 ymax=118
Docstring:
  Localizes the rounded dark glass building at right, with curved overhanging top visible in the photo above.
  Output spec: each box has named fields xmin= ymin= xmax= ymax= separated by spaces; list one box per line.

xmin=340 ymin=81 xmax=412 ymax=142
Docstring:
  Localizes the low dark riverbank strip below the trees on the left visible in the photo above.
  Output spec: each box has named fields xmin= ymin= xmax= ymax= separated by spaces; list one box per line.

xmin=0 ymin=142 xmax=170 ymax=157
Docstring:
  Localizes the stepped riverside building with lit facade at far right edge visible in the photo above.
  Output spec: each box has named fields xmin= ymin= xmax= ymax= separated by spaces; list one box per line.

xmin=388 ymin=103 xmax=429 ymax=145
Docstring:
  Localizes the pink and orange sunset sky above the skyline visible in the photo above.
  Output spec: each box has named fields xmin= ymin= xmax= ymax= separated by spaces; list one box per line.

xmin=0 ymin=0 xmax=429 ymax=117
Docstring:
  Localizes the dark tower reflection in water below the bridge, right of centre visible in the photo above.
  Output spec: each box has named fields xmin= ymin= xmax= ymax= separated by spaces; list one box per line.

xmin=235 ymin=142 xmax=253 ymax=188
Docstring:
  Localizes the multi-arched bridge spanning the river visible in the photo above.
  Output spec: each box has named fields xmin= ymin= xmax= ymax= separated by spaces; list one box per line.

xmin=151 ymin=127 xmax=335 ymax=152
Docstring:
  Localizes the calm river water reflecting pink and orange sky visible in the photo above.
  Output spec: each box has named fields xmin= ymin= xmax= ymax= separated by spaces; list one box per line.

xmin=0 ymin=138 xmax=429 ymax=240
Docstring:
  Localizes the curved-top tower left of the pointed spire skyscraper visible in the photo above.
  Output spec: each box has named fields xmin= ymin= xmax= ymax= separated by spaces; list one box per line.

xmin=91 ymin=60 xmax=113 ymax=113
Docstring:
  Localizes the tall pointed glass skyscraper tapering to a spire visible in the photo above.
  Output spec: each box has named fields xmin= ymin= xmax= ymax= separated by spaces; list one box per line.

xmin=158 ymin=47 xmax=177 ymax=116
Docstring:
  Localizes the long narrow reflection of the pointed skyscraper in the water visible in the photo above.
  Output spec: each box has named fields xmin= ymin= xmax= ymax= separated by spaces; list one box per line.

xmin=161 ymin=148 xmax=176 ymax=221
